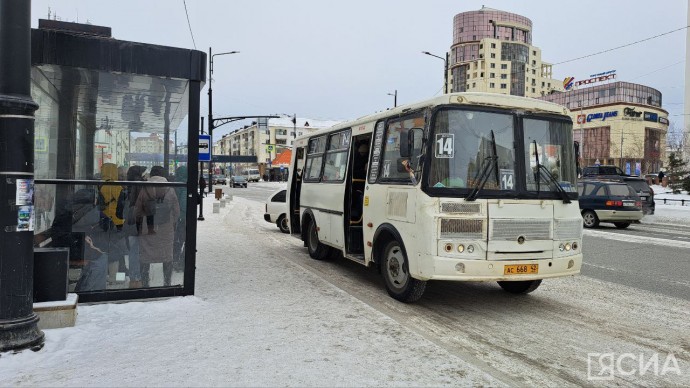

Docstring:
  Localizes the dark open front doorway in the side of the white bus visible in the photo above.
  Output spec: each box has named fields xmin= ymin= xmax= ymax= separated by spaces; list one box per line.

xmin=343 ymin=134 xmax=371 ymax=259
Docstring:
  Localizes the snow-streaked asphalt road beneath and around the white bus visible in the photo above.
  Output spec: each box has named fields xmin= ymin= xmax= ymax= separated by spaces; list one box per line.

xmin=222 ymin=183 xmax=690 ymax=386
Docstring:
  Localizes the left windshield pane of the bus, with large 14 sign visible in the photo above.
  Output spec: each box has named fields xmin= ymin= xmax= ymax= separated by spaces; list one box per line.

xmin=428 ymin=109 xmax=515 ymax=191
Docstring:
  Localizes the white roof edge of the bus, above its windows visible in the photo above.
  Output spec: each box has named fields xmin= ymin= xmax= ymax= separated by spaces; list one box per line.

xmin=297 ymin=92 xmax=569 ymax=139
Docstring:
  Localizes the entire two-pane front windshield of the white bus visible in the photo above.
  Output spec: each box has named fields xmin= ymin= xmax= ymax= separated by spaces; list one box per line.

xmin=427 ymin=109 xmax=577 ymax=198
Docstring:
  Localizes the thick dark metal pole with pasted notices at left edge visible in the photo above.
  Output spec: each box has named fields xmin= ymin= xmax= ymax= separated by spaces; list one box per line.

xmin=0 ymin=1 xmax=45 ymax=352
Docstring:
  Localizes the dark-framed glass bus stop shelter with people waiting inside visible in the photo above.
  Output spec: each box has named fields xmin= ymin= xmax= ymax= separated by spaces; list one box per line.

xmin=31 ymin=20 xmax=206 ymax=302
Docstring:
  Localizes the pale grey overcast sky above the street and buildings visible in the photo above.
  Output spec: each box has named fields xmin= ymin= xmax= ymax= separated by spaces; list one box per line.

xmin=31 ymin=0 xmax=688 ymax=139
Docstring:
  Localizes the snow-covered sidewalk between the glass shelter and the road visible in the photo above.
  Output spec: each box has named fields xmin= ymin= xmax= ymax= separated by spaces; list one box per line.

xmin=0 ymin=197 xmax=501 ymax=386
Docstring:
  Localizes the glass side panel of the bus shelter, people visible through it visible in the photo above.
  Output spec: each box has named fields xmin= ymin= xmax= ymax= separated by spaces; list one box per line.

xmin=32 ymin=67 xmax=188 ymax=292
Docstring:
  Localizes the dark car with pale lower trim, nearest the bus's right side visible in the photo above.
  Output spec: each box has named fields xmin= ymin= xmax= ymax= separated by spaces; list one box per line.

xmin=577 ymin=180 xmax=644 ymax=229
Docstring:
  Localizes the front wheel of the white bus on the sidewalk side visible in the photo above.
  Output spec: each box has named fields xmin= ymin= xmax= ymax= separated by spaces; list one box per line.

xmin=381 ymin=240 xmax=426 ymax=302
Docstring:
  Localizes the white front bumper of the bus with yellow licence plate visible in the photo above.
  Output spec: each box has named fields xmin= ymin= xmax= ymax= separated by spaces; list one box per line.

xmin=420 ymin=253 xmax=582 ymax=281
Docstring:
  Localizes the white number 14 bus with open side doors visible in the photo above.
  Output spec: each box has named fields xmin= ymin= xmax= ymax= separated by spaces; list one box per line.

xmin=287 ymin=93 xmax=582 ymax=302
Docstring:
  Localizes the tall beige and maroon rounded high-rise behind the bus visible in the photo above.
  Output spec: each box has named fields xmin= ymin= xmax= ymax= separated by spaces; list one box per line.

xmin=449 ymin=7 xmax=563 ymax=97
